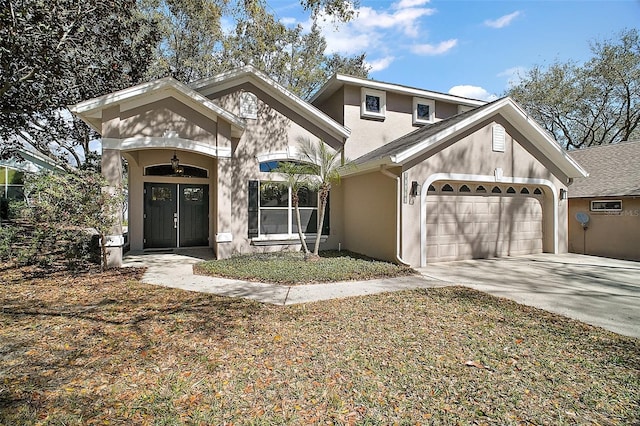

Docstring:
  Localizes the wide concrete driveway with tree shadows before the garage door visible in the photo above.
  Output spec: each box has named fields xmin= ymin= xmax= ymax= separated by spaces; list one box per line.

xmin=420 ymin=254 xmax=640 ymax=337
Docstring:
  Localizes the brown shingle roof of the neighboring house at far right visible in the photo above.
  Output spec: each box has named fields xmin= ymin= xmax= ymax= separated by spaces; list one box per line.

xmin=569 ymin=140 xmax=640 ymax=198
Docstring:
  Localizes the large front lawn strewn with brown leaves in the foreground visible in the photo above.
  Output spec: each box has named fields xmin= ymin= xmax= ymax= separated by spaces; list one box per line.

xmin=0 ymin=269 xmax=640 ymax=425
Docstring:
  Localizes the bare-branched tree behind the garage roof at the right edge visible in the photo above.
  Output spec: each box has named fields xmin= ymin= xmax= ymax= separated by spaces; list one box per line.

xmin=507 ymin=29 xmax=640 ymax=149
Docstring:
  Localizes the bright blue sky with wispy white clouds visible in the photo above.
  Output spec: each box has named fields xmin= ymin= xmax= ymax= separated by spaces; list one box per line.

xmin=267 ymin=0 xmax=640 ymax=100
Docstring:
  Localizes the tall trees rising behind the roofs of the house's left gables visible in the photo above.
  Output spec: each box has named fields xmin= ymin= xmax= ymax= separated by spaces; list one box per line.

xmin=143 ymin=0 xmax=369 ymax=98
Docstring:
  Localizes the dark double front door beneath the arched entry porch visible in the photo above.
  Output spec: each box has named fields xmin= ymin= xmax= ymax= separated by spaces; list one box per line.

xmin=144 ymin=182 xmax=209 ymax=248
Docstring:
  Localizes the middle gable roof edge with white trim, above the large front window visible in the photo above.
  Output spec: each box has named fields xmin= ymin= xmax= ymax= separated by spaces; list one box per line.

xmin=190 ymin=65 xmax=351 ymax=141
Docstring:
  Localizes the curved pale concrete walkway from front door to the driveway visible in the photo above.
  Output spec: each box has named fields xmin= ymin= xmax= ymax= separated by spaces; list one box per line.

xmin=124 ymin=249 xmax=439 ymax=305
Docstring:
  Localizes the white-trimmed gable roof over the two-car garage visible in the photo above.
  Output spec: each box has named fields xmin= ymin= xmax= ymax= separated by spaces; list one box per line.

xmin=345 ymin=97 xmax=587 ymax=178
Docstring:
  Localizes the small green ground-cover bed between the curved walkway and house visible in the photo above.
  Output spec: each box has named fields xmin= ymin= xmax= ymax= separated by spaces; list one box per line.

xmin=194 ymin=251 xmax=416 ymax=285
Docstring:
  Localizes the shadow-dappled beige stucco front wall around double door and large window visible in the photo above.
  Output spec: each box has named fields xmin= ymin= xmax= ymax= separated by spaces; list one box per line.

xmin=117 ymin=89 xmax=341 ymax=257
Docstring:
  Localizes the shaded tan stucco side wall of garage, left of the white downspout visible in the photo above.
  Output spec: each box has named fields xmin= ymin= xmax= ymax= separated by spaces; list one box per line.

xmin=341 ymin=172 xmax=397 ymax=261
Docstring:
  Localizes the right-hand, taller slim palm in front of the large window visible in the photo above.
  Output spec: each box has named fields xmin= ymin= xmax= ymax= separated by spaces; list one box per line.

xmin=300 ymin=139 xmax=348 ymax=257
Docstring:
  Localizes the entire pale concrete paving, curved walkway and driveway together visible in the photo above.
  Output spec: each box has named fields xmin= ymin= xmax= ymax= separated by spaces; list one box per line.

xmin=124 ymin=249 xmax=640 ymax=337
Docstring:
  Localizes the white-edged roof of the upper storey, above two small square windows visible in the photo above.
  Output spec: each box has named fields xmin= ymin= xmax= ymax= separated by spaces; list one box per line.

xmin=309 ymin=74 xmax=486 ymax=106
